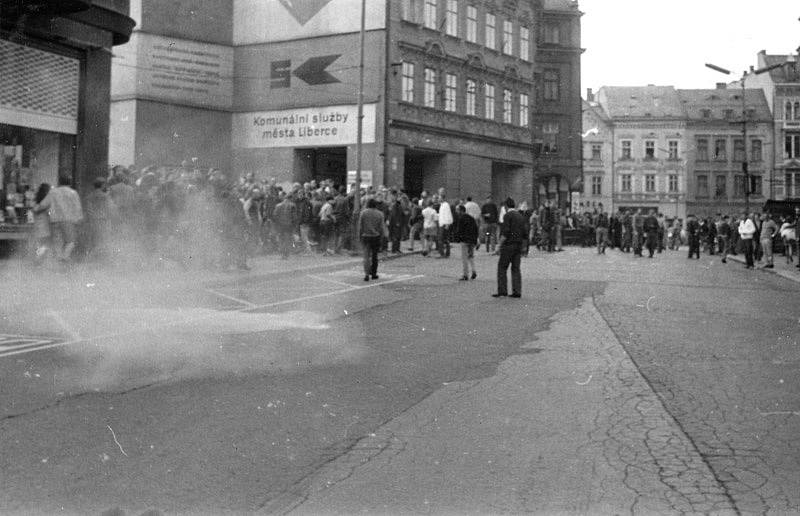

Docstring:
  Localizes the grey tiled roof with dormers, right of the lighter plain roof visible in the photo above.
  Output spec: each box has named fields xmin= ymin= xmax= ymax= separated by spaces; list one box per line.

xmin=678 ymin=88 xmax=772 ymax=121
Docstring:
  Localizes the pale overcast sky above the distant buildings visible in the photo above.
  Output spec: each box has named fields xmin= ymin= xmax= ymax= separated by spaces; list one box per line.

xmin=580 ymin=0 xmax=800 ymax=92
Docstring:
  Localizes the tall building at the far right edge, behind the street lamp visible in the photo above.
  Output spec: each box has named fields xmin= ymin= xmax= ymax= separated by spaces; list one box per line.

xmin=745 ymin=48 xmax=800 ymax=200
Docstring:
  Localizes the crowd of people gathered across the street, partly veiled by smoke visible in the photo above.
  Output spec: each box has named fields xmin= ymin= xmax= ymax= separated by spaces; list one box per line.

xmin=18 ymin=162 xmax=800 ymax=280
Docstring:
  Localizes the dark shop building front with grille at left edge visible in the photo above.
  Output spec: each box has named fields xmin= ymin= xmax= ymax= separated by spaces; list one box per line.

xmin=0 ymin=0 xmax=133 ymax=222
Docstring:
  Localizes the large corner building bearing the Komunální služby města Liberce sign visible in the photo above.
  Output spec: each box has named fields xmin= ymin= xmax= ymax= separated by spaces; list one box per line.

xmin=112 ymin=0 xmax=581 ymax=206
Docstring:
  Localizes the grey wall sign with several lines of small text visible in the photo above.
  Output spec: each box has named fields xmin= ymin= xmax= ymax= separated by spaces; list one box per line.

xmin=113 ymin=32 xmax=233 ymax=108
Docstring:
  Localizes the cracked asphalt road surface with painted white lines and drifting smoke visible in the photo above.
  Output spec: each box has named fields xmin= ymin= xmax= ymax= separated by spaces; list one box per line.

xmin=0 ymin=248 xmax=800 ymax=515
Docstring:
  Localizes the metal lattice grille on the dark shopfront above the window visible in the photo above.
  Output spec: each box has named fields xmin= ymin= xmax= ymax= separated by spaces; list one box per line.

xmin=0 ymin=40 xmax=80 ymax=120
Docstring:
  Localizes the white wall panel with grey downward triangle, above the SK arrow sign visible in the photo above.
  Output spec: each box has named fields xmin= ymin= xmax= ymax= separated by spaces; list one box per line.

xmin=233 ymin=0 xmax=386 ymax=45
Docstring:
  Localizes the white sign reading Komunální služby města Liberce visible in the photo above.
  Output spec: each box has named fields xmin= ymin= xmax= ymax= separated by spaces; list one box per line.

xmin=233 ymin=104 xmax=376 ymax=149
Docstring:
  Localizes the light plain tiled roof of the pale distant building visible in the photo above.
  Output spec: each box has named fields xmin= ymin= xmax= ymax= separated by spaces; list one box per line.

xmin=597 ymin=85 xmax=685 ymax=118
